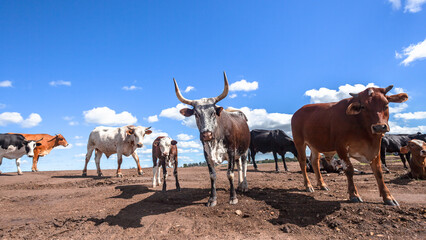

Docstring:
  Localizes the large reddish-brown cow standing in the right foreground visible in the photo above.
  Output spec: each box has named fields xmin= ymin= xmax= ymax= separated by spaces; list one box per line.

xmin=291 ymin=85 xmax=408 ymax=206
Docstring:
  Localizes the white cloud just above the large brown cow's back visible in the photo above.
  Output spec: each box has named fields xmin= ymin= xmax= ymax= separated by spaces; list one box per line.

xmin=305 ymin=83 xmax=378 ymax=103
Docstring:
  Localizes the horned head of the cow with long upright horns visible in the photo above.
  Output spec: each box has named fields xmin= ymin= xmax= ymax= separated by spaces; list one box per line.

xmin=173 ymin=72 xmax=229 ymax=141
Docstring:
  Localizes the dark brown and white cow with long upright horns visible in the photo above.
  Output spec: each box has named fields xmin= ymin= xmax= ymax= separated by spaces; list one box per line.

xmin=173 ymin=72 xmax=250 ymax=207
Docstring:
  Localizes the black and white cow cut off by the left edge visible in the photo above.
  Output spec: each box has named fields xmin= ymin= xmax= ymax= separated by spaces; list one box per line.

xmin=0 ymin=134 xmax=43 ymax=175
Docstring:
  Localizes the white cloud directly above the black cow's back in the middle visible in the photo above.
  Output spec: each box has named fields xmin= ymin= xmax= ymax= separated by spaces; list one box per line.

xmin=240 ymin=107 xmax=292 ymax=132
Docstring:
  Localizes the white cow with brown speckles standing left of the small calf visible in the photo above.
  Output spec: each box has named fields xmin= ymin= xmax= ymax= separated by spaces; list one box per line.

xmin=83 ymin=125 xmax=152 ymax=177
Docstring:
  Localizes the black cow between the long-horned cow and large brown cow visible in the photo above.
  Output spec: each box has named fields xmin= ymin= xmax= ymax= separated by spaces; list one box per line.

xmin=250 ymin=129 xmax=297 ymax=172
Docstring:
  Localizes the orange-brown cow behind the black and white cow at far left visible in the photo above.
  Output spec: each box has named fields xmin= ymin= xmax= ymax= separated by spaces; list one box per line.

xmin=10 ymin=133 xmax=68 ymax=172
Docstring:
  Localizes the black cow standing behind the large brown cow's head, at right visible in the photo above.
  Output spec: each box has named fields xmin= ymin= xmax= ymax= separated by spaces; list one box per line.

xmin=380 ymin=134 xmax=411 ymax=172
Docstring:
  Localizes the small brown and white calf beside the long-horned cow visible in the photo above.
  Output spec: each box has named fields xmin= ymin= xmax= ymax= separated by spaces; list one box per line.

xmin=152 ymin=136 xmax=180 ymax=192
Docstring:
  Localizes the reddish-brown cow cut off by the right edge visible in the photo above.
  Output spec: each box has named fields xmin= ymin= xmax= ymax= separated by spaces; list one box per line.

xmin=400 ymin=139 xmax=426 ymax=180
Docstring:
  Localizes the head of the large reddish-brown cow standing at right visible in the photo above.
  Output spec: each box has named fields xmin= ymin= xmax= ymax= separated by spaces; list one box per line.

xmin=346 ymin=85 xmax=408 ymax=134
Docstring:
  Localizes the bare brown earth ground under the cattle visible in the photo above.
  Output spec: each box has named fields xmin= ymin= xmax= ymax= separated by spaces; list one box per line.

xmin=0 ymin=155 xmax=426 ymax=239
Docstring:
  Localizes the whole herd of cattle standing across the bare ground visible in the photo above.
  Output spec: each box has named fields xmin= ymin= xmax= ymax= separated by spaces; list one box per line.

xmin=0 ymin=73 xmax=426 ymax=206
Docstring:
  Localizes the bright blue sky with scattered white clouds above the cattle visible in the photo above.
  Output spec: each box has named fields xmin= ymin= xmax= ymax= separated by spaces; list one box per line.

xmin=0 ymin=0 xmax=426 ymax=172
